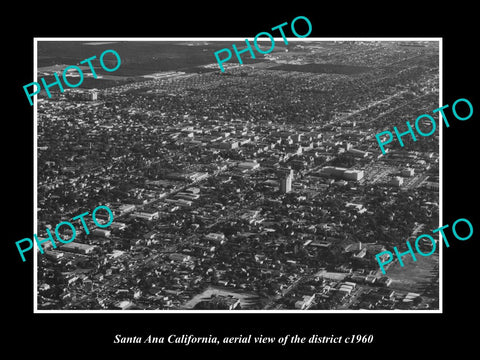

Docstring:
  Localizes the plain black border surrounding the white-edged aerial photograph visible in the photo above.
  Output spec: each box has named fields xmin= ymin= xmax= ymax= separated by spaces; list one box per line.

xmin=6 ymin=3 xmax=480 ymax=357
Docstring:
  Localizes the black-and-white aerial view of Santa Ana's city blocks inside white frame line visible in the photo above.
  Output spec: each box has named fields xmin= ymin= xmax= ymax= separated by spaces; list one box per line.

xmin=36 ymin=39 xmax=441 ymax=311
